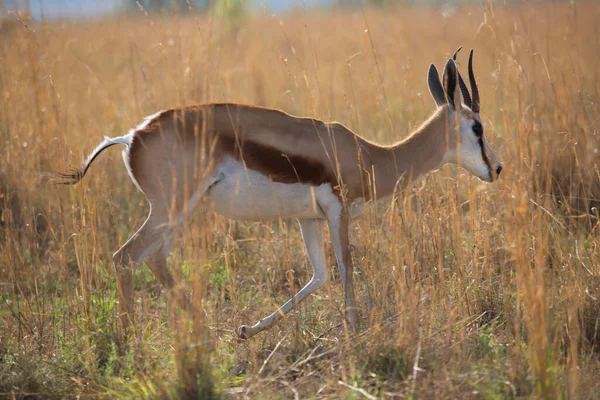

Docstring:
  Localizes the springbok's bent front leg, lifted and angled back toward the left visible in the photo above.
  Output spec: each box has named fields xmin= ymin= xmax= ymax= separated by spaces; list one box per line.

xmin=237 ymin=219 xmax=328 ymax=339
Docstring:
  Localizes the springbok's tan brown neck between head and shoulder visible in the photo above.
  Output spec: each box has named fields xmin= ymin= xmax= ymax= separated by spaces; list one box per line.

xmin=374 ymin=108 xmax=448 ymax=199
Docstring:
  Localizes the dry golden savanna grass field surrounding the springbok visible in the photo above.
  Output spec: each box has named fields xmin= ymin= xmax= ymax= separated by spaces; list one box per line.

xmin=0 ymin=2 xmax=600 ymax=399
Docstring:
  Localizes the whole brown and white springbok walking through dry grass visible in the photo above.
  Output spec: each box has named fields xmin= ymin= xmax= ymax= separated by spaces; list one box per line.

xmin=59 ymin=48 xmax=502 ymax=339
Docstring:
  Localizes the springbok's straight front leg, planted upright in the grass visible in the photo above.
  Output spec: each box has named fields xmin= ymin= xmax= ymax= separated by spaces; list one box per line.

xmin=325 ymin=202 xmax=358 ymax=332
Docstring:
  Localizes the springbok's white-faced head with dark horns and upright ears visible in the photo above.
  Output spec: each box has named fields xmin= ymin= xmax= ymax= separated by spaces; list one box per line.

xmin=428 ymin=48 xmax=502 ymax=182
